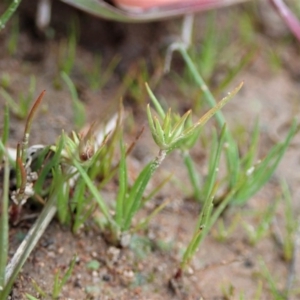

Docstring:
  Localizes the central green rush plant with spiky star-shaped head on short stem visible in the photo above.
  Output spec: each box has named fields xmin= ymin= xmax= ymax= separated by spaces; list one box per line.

xmin=73 ymin=84 xmax=242 ymax=246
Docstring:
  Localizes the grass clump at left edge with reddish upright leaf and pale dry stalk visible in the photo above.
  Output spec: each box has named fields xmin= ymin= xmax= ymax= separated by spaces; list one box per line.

xmin=0 ymin=91 xmax=94 ymax=300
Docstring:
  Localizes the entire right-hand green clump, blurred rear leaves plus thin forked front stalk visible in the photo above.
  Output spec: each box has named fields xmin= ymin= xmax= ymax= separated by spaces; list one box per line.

xmin=164 ymin=46 xmax=298 ymax=284
